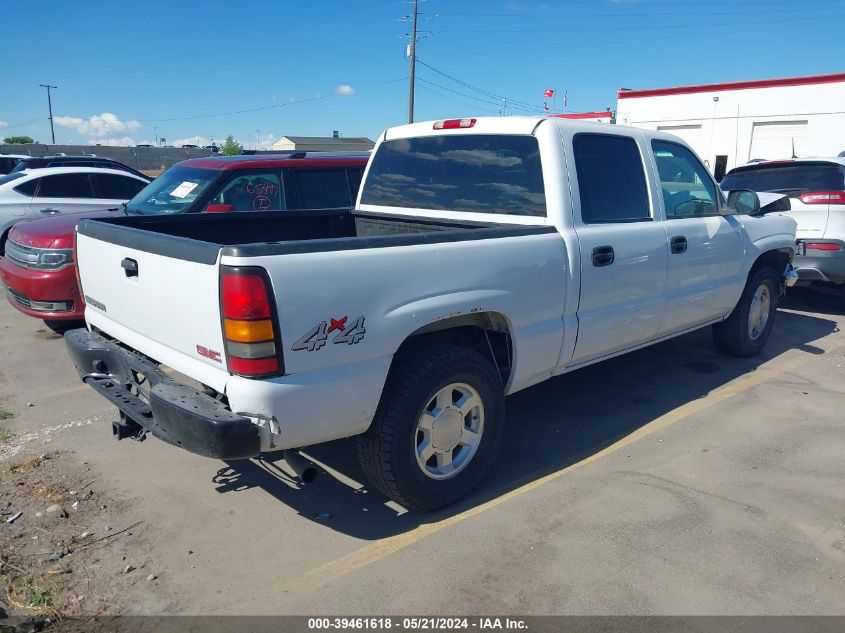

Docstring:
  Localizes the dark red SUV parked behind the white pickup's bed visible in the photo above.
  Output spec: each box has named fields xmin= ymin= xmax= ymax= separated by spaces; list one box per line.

xmin=0 ymin=152 xmax=368 ymax=332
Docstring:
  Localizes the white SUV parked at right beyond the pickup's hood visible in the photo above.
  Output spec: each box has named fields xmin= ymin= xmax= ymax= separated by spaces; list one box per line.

xmin=722 ymin=157 xmax=845 ymax=303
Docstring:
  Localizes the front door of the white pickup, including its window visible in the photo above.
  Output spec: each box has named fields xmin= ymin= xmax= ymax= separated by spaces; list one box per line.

xmin=651 ymin=139 xmax=745 ymax=335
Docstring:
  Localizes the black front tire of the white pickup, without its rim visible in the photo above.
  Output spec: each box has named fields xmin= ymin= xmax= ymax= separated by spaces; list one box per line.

xmin=713 ymin=266 xmax=780 ymax=358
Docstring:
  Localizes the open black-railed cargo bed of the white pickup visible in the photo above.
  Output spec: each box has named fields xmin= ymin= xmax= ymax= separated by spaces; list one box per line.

xmin=78 ymin=209 xmax=555 ymax=264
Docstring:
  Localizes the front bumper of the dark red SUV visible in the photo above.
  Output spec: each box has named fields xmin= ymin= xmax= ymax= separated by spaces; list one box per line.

xmin=0 ymin=257 xmax=85 ymax=320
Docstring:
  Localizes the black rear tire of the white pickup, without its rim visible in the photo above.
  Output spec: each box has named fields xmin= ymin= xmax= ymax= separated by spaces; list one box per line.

xmin=358 ymin=343 xmax=505 ymax=512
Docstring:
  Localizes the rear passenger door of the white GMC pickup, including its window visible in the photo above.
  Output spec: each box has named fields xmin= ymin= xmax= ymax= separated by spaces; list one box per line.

xmin=567 ymin=130 xmax=668 ymax=364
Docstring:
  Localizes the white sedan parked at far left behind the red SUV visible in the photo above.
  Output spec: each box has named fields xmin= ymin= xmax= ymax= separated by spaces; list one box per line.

xmin=0 ymin=167 xmax=149 ymax=236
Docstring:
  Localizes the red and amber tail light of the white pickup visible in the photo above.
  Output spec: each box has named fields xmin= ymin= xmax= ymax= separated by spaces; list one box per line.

xmin=220 ymin=266 xmax=284 ymax=378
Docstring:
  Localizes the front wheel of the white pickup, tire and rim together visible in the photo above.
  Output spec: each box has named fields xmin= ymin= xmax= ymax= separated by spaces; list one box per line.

xmin=713 ymin=267 xmax=780 ymax=358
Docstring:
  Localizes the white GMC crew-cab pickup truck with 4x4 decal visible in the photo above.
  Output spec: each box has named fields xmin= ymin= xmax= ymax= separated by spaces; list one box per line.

xmin=66 ymin=117 xmax=795 ymax=510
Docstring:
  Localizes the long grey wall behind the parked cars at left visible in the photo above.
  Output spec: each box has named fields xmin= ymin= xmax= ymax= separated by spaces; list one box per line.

xmin=0 ymin=143 xmax=212 ymax=171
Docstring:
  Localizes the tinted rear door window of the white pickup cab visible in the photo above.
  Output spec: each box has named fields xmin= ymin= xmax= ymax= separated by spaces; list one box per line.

xmin=572 ymin=134 xmax=651 ymax=224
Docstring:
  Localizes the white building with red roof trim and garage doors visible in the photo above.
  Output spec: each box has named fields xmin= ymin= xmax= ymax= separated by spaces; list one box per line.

xmin=616 ymin=73 xmax=845 ymax=179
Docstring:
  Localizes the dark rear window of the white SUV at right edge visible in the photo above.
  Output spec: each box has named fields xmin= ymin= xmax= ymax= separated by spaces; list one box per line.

xmin=719 ymin=161 xmax=845 ymax=196
